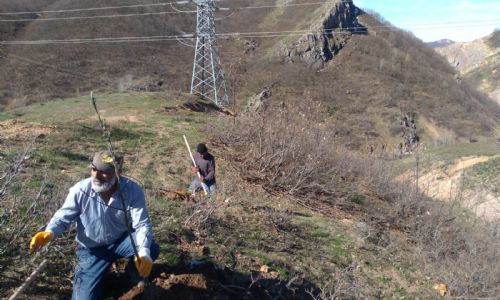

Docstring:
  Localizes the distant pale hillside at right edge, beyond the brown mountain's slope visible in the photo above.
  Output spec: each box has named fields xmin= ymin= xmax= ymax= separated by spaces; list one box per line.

xmin=436 ymin=31 xmax=500 ymax=105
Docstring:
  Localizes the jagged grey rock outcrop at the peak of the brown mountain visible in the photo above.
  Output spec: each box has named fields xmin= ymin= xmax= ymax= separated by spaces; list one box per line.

xmin=278 ymin=0 xmax=365 ymax=69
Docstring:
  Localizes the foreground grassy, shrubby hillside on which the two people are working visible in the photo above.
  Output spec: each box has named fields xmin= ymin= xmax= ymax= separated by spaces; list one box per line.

xmin=0 ymin=93 xmax=500 ymax=299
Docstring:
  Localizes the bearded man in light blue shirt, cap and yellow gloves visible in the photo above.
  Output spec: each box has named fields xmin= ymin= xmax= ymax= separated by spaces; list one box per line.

xmin=30 ymin=151 xmax=160 ymax=300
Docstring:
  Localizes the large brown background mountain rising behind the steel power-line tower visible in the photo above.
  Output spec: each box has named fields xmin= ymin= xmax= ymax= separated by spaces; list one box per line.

xmin=0 ymin=0 xmax=500 ymax=151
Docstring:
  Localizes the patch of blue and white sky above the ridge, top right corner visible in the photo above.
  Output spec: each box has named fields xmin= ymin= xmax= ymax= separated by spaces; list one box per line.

xmin=354 ymin=0 xmax=500 ymax=42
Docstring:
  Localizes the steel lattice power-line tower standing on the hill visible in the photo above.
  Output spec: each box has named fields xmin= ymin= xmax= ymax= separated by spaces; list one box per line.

xmin=191 ymin=0 xmax=229 ymax=106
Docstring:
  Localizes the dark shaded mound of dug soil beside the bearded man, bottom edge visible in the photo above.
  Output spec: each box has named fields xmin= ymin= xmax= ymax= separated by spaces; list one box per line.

xmin=111 ymin=261 xmax=318 ymax=300
